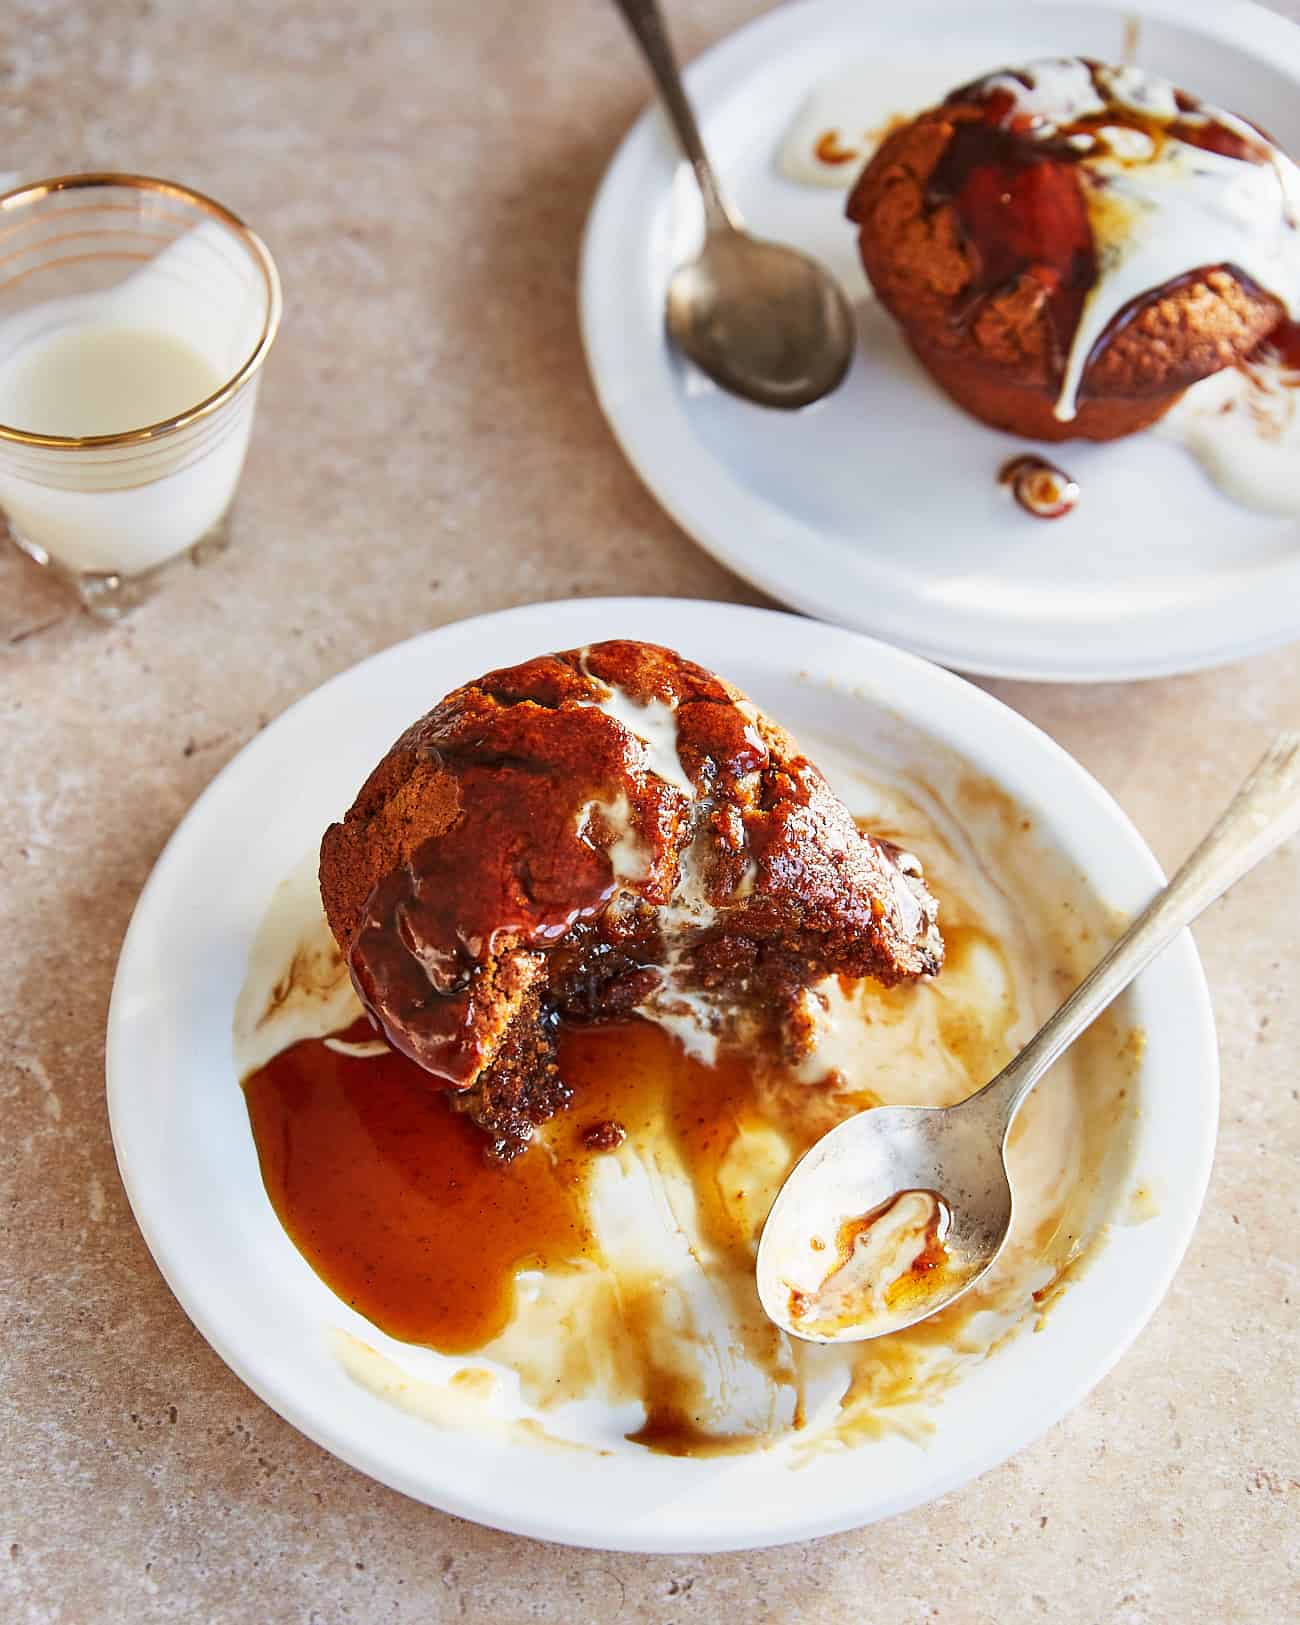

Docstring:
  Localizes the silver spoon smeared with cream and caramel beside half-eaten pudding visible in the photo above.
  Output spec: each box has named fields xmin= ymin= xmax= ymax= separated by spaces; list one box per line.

xmin=757 ymin=733 xmax=1300 ymax=1342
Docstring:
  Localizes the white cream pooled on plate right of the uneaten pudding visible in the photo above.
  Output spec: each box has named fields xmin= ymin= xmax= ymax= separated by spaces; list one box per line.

xmin=1155 ymin=351 xmax=1300 ymax=514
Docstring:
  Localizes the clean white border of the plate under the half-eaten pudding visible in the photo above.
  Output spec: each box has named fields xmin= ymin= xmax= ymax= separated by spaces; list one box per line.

xmin=107 ymin=598 xmax=1217 ymax=1552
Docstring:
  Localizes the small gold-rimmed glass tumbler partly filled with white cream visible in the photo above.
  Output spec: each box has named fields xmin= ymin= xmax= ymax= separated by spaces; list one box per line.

xmin=0 ymin=174 xmax=281 ymax=618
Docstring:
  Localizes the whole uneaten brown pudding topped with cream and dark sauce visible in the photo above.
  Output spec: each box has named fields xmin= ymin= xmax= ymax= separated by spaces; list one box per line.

xmin=848 ymin=57 xmax=1300 ymax=440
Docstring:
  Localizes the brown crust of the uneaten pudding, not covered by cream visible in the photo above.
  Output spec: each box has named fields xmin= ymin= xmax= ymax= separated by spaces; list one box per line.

xmin=848 ymin=78 xmax=1282 ymax=440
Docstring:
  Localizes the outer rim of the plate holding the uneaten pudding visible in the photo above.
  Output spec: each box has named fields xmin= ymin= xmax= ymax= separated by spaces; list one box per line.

xmin=577 ymin=0 xmax=1300 ymax=683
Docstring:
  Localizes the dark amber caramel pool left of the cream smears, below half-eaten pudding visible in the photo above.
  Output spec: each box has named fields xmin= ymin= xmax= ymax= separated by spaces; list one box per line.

xmin=244 ymin=1021 xmax=592 ymax=1354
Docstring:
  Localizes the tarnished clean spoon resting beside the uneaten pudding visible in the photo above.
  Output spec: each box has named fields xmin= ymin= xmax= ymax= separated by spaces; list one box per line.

xmin=616 ymin=0 xmax=855 ymax=406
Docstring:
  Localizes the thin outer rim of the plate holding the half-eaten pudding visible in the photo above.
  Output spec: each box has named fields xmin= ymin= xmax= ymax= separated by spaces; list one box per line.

xmin=106 ymin=598 xmax=1219 ymax=1554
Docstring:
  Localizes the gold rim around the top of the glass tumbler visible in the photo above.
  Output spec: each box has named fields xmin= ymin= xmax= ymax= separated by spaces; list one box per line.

xmin=0 ymin=171 xmax=281 ymax=452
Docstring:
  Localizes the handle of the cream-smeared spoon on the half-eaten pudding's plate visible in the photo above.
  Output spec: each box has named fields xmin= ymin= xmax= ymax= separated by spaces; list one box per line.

xmin=972 ymin=733 xmax=1300 ymax=1129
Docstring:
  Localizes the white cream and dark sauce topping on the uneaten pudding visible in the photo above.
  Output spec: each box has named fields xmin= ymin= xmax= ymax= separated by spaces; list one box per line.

xmin=926 ymin=57 xmax=1300 ymax=421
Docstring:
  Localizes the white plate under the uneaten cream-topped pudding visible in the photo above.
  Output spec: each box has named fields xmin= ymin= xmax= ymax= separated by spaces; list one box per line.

xmin=582 ymin=0 xmax=1300 ymax=681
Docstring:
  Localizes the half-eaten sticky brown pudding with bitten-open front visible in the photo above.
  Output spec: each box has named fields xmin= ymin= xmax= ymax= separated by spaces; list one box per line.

xmin=320 ymin=642 xmax=943 ymax=1160
